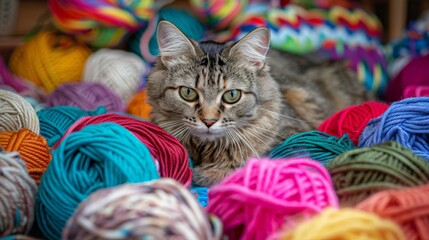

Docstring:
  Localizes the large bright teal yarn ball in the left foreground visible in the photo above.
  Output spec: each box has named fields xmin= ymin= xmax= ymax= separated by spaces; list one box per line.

xmin=36 ymin=122 xmax=159 ymax=239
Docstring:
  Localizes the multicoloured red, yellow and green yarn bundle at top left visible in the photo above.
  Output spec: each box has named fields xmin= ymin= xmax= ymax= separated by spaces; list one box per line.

xmin=49 ymin=0 xmax=155 ymax=47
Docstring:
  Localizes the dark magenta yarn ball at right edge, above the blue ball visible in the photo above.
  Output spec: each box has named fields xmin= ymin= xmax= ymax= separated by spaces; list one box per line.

xmin=386 ymin=55 xmax=429 ymax=102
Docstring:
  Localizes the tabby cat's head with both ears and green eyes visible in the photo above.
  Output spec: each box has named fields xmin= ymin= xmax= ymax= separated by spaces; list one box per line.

xmin=148 ymin=22 xmax=277 ymax=146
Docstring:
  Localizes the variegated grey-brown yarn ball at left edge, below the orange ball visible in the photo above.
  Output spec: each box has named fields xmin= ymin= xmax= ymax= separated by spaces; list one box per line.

xmin=0 ymin=151 xmax=37 ymax=238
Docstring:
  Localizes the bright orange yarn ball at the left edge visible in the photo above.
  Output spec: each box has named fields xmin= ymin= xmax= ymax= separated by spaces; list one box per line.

xmin=0 ymin=128 xmax=52 ymax=184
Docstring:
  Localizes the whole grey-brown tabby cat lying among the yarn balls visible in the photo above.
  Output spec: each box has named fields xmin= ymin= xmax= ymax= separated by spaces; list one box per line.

xmin=146 ymin=21 xmax=371 ymax=186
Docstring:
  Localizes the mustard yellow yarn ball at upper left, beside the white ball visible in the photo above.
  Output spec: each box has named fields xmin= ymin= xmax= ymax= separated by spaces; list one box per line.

xmin=9 ymin=31 xmax=91 ymax=92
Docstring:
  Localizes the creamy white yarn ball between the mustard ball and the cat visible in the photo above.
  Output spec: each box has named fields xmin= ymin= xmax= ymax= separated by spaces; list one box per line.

xmin=84 ymin=48 xmax=145 ymax=103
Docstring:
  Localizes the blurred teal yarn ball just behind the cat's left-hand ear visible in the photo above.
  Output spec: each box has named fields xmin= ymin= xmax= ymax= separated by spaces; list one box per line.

xmin=129 ymin=7 xmax=205 ymax=62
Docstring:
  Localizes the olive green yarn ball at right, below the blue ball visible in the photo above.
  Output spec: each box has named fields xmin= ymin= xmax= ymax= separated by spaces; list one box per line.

xmin=326 ymin=141 xmax=429 ymax=206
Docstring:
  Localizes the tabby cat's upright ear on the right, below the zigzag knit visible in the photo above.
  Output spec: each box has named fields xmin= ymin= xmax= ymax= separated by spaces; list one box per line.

xmin=230 ymin=27 xmax=270 ymax=69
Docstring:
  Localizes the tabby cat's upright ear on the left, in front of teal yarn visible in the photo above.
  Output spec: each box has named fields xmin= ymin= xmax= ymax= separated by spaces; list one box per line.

xmin=157 ymin=20 xmax=195 ymax=67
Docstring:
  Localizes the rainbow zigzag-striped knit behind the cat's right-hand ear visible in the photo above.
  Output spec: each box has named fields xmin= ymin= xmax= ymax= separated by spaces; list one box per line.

xmin=217 ymin=4 xmax=382 ymax=54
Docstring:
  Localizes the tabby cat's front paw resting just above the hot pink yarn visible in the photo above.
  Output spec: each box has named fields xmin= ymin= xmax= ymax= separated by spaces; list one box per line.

xmin=192 ymin=166 xmax=234 ymax=187
